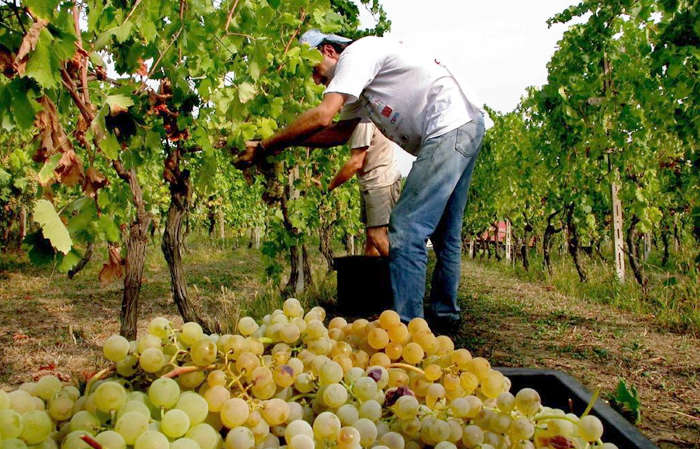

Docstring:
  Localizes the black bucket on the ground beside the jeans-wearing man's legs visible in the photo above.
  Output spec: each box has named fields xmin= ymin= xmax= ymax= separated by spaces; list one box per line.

xmin=333 ymin=256 xmax=393 ymax=316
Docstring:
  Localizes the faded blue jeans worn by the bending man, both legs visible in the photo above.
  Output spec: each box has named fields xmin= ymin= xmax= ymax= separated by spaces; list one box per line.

xmin=389 ymin=115 xmax=484 ymax=321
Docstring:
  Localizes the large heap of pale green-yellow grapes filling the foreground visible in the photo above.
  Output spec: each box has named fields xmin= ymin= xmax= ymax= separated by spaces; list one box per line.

xmin=0 ymin=298 xmax=615 ymax=449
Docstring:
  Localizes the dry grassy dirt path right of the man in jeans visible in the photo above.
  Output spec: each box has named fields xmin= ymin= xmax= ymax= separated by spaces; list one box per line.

xmin=457 ymin=260 xmax=700 ymax=448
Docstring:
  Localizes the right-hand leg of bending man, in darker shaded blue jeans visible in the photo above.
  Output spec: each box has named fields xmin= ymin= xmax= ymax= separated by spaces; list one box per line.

xmin=430 ymin=114 xmax=483 ymax=320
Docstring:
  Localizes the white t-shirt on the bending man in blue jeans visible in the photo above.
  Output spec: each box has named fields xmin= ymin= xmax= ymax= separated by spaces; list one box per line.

xmin=326 ymin=36 xmax=481 ymax=155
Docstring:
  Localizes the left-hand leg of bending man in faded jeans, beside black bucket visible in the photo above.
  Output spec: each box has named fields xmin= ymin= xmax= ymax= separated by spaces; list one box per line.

xmin=389 ymin=121 xmax=483 ymax=321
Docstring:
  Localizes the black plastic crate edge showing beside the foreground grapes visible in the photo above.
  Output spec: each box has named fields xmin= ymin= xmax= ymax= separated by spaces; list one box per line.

xmin=495 ymin=368 xmax=658 ymax=449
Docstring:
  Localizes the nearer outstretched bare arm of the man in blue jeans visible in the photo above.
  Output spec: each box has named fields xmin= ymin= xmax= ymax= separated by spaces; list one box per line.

xmin=236 ymin=92 xmax=347 ymax=166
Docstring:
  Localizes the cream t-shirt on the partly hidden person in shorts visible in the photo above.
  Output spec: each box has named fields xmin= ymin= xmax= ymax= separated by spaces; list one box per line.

xmin=350 ymin=121 xmax=401 ymax=190
